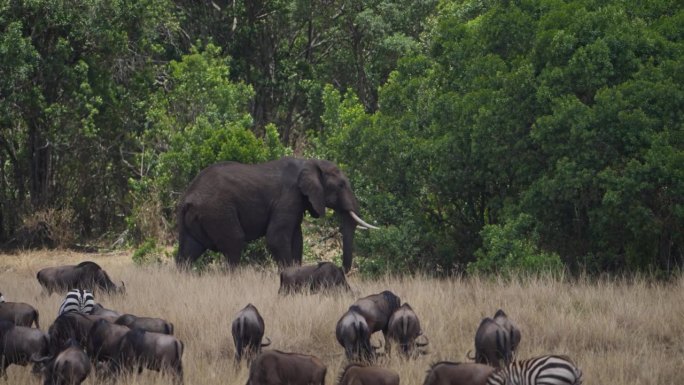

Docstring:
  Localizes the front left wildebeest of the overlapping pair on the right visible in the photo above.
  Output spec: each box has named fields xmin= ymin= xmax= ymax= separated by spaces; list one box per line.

xmin=475 ymin=317 xmax=513 ymax=368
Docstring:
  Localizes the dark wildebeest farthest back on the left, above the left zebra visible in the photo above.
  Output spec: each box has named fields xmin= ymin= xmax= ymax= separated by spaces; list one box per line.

xmin=36 ymin=261 xmax=126 ymax=295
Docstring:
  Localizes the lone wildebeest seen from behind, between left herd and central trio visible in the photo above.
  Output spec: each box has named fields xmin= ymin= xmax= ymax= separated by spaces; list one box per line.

xmin=231 ymin=303 xmax=271 ymax=362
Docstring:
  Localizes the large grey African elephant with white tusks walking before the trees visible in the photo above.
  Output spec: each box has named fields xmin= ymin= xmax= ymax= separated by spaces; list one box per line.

xmin=176 ymin=157 xmax=376 ymax=271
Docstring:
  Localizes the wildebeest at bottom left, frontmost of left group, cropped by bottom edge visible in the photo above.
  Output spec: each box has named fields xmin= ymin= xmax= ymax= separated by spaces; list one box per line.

xmin=32 ymin=339 xmax=90 ymax=385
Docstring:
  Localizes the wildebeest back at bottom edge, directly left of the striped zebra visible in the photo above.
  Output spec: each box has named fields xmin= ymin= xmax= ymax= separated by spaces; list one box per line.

xmin=423 ymin=361 xmax=496 ymax=385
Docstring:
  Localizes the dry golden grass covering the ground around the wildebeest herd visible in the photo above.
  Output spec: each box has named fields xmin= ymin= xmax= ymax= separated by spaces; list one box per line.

xmin=0 ymin=252 xmax=684 ymax=385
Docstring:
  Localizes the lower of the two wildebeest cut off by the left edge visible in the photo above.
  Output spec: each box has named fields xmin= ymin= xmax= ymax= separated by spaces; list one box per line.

xmin=0 ymin=321 xmax=49 ymax=378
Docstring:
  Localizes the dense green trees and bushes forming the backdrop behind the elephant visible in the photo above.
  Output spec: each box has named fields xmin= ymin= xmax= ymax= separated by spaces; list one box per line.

xmin=0 ymin=0 xmax=684 ymax=273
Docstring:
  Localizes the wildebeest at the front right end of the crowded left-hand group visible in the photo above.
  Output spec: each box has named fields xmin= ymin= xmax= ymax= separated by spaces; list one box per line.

xmin=116 ymin=328 xmax=184 ymax=384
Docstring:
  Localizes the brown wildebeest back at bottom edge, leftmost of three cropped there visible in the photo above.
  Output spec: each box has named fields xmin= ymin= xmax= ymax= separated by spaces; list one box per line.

xmin=247 ymin=350 xmax=327 ymax=385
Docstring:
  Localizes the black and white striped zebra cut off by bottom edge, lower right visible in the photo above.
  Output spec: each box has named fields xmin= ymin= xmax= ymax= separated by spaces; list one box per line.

xmin=487 ymin=355 xmax=582 ymax=385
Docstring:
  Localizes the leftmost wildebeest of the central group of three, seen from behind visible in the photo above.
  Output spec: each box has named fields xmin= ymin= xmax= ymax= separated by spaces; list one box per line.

xmin=335 ymin=306 xmax=375 ymax=362
